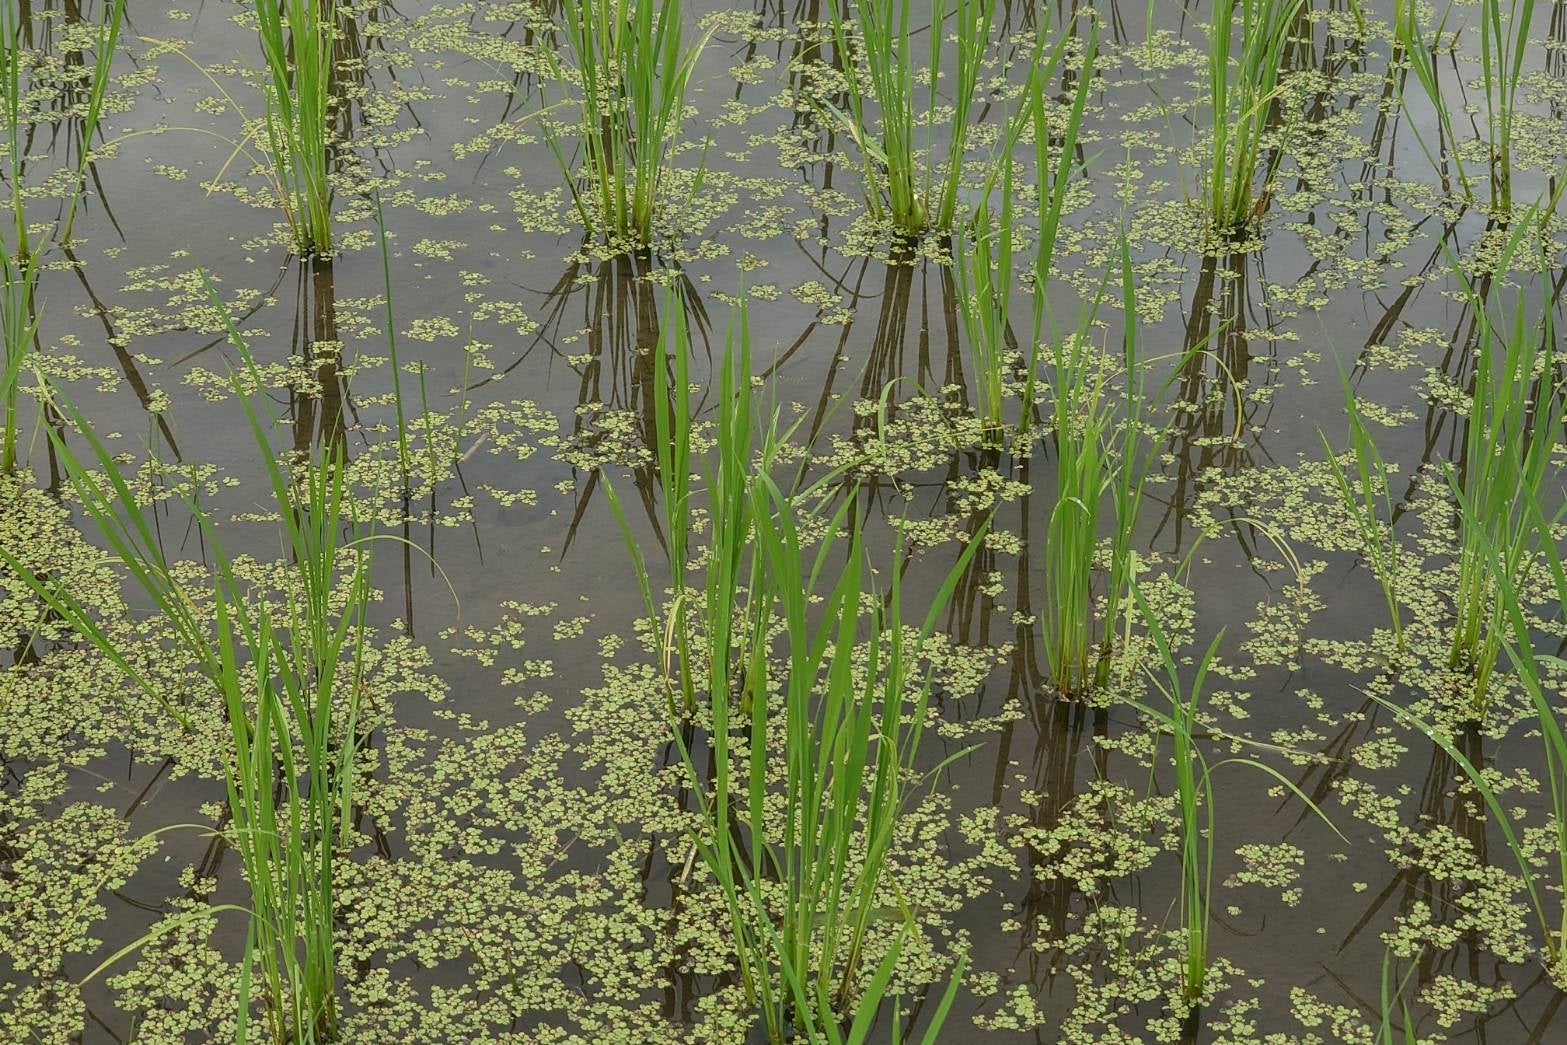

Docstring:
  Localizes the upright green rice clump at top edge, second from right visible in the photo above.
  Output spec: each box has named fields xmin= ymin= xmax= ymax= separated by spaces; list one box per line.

xmin=1203 ymin=0 xmax=1305 ymax=238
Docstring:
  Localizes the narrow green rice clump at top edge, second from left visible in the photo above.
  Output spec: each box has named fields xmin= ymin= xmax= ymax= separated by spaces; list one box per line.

xmin=255 ymin=0 xmax=337 ymax=254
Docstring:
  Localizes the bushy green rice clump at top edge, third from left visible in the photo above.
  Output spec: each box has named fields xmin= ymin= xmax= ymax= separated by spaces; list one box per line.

xmin=542 ymin=0 xmax=713 ymax=246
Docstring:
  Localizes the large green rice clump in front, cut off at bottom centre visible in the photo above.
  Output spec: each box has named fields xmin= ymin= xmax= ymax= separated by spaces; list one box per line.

xmin=741 ymin=485 xmax=978 ymax=1042
